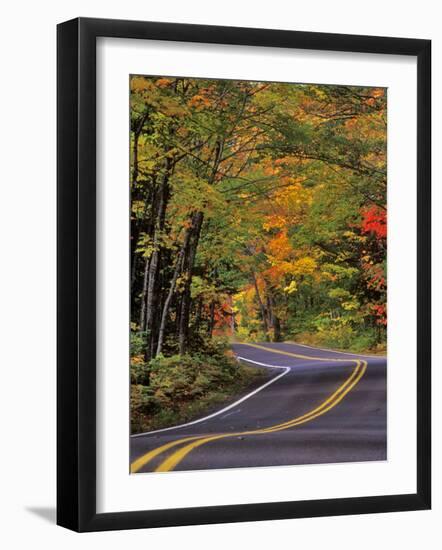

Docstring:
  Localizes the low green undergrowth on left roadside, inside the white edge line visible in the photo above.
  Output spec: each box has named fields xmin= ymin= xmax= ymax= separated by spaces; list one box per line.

xmin=130 ymin=342 xmax=267 ymax=434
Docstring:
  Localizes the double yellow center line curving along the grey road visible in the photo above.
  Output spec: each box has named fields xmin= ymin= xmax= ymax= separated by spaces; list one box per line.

xmin=130 ymin=344 xmax=367 ymax=473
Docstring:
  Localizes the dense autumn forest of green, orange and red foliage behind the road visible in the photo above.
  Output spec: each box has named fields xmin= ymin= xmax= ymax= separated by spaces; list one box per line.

xmin=130 ymin=76 xmax=387 ymax=434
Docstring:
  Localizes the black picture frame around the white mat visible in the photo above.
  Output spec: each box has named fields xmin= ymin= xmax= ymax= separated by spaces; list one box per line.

xmin=57 ymin=18 xmax=431 ymax=531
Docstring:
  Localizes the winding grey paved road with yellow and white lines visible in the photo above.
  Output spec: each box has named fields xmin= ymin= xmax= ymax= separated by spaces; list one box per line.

xmin=130 ymin=343 xmax=387 ymax=472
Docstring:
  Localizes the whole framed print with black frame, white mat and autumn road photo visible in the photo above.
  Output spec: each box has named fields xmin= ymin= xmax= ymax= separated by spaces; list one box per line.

xmin=57 ymin=18 xmax=431 ymax=531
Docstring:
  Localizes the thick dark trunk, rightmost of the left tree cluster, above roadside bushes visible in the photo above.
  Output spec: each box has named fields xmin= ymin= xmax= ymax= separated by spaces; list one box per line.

xmin=178 ymin=212 xmax=204 ymax=355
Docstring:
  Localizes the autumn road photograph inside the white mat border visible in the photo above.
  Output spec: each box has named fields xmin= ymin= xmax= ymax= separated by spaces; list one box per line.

xmin=129 ymin=74 xmax=387 ymax=473
